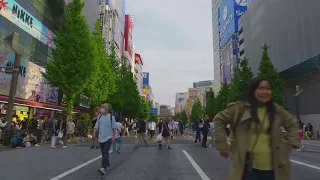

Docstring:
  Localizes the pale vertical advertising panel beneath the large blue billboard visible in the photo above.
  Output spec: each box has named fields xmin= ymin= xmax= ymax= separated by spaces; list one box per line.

xmin=221 ymin=39 xmax=233 ymax=84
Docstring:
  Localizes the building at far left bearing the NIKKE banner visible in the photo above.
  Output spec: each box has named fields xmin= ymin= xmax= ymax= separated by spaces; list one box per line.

xmin=0 ymin=0 xmax=64 ymax=119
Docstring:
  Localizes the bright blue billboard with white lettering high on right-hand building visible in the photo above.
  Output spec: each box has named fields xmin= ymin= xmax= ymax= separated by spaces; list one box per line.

xmin=219 ymin=0 xmax=247 ymax=48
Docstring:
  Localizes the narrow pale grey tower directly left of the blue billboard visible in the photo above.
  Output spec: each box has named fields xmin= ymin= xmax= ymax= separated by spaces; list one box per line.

xmin=211 ymin=0 xmax=221 ymax=93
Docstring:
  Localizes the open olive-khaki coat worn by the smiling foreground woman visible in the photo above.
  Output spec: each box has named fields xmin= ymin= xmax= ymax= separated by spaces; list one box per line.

xmin=214 ymin=102 xmax=299 ymax=180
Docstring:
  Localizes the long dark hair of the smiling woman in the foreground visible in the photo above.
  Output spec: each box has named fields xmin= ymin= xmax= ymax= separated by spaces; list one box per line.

xmin=241 ymin=78 xmax=276 ymax=133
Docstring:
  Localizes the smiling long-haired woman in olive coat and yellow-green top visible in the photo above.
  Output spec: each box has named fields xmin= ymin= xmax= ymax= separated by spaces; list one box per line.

xmin=214 ymin=78 xmax=299 ymax=180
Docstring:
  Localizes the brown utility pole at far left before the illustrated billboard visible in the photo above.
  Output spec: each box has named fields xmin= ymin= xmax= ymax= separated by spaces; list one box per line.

xmin=4 ymin=32 xmax=21 ymax=127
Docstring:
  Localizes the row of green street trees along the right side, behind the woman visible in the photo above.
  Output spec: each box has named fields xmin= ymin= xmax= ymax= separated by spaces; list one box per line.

xmin=188 ymin=44 xmax=284 ymax=121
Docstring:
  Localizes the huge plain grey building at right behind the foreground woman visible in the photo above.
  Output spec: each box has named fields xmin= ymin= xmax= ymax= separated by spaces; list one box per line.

xmin=243 ymin=0 xmax=320 ymax=128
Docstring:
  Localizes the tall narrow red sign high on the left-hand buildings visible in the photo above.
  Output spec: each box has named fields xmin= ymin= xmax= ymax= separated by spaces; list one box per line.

xmin=124 ymin=15 xmax=133 ymax=57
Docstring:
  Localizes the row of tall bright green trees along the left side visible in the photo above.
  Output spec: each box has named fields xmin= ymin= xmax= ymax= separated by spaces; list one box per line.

xmin=43 ymin=0 xmax=150 ymax=118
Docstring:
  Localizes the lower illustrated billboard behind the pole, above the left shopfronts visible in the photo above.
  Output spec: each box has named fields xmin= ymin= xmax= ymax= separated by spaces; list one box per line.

xmin=0 ymin=44 xmax=58 ymax=104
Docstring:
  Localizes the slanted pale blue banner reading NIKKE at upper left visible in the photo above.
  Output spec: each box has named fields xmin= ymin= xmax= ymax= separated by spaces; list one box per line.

xmin=0 ymin=0 xmax=55 ymax=48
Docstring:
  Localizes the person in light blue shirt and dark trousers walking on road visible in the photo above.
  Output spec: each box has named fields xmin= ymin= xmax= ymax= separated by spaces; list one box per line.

xmin=93 ymin=103 xmax=117 ymax=175
